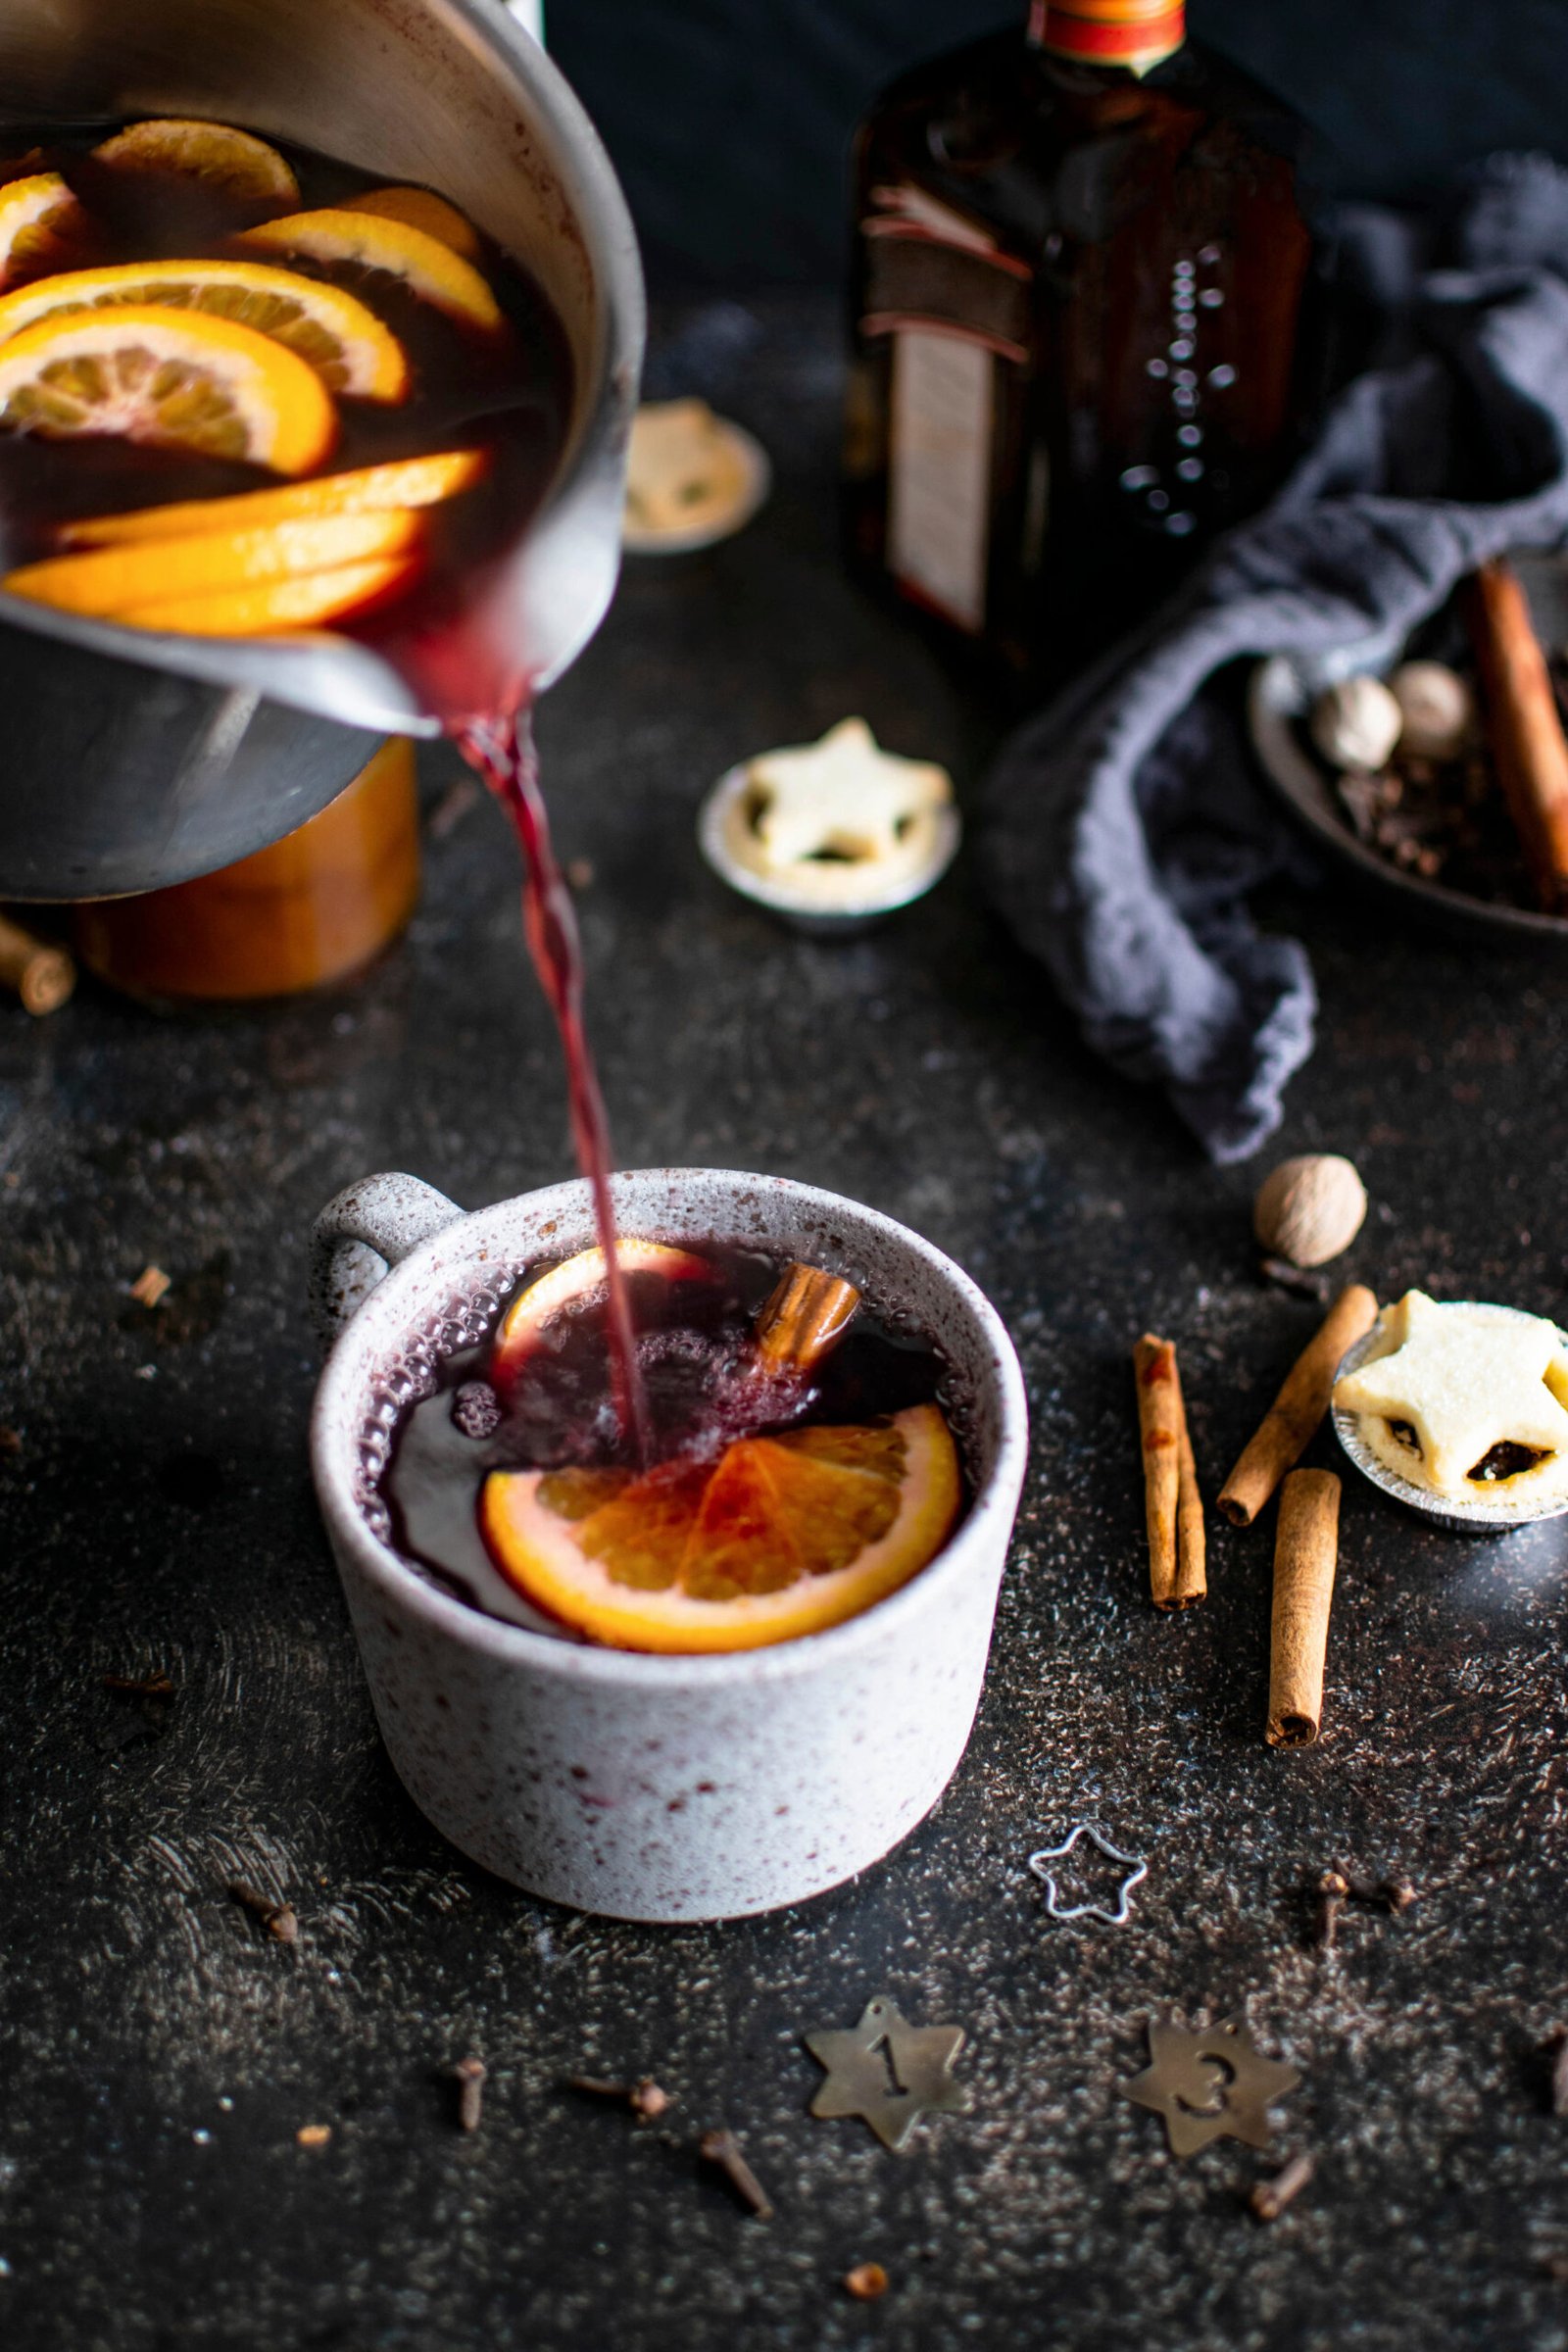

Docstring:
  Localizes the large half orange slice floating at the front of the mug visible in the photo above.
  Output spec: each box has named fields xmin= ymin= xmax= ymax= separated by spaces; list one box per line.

xmin=479 ymin=1404 xmax=961 ymax=1651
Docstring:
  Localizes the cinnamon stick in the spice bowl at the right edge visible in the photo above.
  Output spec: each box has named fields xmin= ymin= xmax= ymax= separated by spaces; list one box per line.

xmin=1462 ymin=563 xmax=1568 ymax=915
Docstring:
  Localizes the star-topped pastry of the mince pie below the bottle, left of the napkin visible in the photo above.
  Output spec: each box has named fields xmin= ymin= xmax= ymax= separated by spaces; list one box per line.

xmin=726 ymin=719 xmax=953 ymax=904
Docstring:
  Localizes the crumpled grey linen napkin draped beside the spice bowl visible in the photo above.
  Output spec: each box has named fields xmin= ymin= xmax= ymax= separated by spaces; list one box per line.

xmin=980 ymin=155 xmax=1568 ymax=1162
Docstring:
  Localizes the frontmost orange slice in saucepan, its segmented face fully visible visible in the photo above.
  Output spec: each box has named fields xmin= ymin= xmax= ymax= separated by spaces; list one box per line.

xmin=0 ymin=304 xmax=338 ymax=472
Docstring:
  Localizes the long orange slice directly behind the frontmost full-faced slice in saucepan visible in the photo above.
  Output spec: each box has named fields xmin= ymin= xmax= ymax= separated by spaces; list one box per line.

xmin=0 ymin=261 xmax=409 ymax=400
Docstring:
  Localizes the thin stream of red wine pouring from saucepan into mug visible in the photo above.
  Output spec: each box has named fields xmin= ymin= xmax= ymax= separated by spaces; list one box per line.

xmin=456 ymin=708 xmax=651 ymax=1463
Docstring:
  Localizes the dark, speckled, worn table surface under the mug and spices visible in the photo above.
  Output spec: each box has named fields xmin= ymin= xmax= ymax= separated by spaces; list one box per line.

xmin=0 ymin=311 xmax=1568 ymax=2352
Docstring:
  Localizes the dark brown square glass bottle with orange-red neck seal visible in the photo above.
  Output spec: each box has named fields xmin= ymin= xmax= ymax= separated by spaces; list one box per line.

xmin=844 ymin=0 xmax=1321 ymax=677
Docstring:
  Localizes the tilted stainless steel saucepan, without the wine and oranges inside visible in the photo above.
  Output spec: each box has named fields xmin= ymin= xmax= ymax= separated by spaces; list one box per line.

xmin=0 ymin=0 xmax=644 ymax=899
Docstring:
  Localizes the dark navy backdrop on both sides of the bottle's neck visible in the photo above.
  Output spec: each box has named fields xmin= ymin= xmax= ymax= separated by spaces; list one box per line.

xmin=546 ymin=0 xmax=1568 ymax=289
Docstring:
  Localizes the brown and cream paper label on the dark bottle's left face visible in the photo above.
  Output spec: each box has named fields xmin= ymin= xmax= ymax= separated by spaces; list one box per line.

xmin=860 ymin=186 xmax=1032 ymax=635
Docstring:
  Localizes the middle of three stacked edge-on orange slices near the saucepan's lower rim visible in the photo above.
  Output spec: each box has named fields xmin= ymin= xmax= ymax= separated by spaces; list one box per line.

xmin=0 ymin=513 xmax=425 ymax=615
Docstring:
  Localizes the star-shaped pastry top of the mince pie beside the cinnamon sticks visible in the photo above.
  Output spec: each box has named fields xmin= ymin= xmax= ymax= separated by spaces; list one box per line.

xmin=1333 ymin=1292 xmax=1568 ymax=1495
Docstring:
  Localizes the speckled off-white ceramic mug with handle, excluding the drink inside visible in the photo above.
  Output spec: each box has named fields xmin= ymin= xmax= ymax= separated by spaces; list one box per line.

xmin=311 ymin=1169 xmax=1027 ymax=1919
